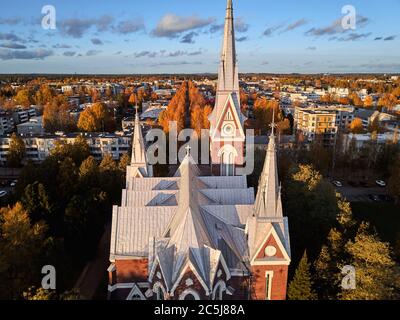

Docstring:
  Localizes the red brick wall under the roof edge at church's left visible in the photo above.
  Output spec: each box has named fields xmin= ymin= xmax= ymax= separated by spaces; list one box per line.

xmin=115 ymin=259 xmax=148 ymax=283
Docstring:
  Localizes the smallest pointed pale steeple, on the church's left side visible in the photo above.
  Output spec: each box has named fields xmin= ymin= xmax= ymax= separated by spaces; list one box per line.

xmin=130 ymin=105 xmax=153 ymax=177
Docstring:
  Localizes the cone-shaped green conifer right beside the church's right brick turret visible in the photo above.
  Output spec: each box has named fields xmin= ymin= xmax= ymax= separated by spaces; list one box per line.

xmin=288 ymin=251 xmax=317 ymax=300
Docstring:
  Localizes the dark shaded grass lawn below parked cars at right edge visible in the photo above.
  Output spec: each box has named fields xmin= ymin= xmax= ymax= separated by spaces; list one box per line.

xmin=351 ymin=202 xmax=400 ymax=246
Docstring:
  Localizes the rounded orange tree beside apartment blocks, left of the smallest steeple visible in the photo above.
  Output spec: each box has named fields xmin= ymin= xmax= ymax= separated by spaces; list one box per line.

xmin=78 ymin=103 xmax=115 ymax=132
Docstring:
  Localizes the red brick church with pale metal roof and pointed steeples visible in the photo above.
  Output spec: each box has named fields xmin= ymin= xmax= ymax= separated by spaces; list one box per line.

xmin=107 ymin=0 xmax=291 ymax=300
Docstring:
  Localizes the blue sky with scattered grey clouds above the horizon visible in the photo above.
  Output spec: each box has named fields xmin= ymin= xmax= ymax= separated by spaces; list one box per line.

xmin=0 ymin=0 xmax=400 ymax=74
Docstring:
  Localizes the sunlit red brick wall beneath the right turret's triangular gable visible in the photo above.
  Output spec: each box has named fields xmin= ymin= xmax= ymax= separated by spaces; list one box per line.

xmin=252 ymin=266 xmax=288 ymax=300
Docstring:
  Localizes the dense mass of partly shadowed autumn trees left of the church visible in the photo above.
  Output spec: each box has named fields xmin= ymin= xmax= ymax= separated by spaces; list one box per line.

xmin=0 ymin=138 xmax=129 ymax=299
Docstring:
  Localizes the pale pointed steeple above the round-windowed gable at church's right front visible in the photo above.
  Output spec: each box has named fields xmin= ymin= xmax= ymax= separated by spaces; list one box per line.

xmin=254 ymin=111 xmax=282 ymax=217
